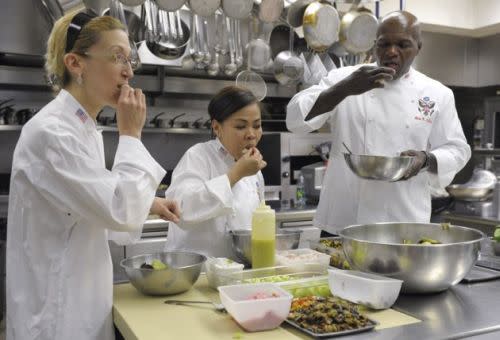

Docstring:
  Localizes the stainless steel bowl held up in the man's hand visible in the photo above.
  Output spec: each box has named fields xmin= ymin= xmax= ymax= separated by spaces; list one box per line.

xmin=344 ymin=153 xmax=414 ymax=182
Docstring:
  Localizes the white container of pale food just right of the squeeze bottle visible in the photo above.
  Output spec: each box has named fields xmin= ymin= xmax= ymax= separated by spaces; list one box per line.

xmin=276 ymin=249 xmax=330 ymax=271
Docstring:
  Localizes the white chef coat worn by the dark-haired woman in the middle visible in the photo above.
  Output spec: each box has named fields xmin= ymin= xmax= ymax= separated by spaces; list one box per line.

xmin=165 ymin=139 xmax=264 ymax=260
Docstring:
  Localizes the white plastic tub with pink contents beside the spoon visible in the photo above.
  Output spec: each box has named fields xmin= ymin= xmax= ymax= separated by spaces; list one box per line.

xmin=219 ymin=283 xmax=293 ymax=332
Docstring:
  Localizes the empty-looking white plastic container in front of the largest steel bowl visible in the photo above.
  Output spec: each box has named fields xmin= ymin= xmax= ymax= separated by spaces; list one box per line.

xmin=328 ymin=269 xmax=403 ymax=309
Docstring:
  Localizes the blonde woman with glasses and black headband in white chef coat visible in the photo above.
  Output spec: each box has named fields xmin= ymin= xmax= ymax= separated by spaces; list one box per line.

xmin=7 ymin=13 xmax=182 ymax=340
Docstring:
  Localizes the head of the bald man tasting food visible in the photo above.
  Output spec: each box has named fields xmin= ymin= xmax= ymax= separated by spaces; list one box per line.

xmin=375 ymin=11 xmax=422 ymax=79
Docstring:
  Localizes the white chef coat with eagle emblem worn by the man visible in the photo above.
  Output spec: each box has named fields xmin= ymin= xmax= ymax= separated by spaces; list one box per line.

xmin=286 ymin=65 xmax=471 ymax=233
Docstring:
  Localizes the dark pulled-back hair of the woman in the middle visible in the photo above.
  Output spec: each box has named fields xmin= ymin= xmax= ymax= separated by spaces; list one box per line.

xmin=208 ymin=86 xmax=259 ymax=123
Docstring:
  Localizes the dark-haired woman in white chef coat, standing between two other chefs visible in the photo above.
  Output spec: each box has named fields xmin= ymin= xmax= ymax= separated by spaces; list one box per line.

xmin=166 ymin=86 xmax=266 ymax=259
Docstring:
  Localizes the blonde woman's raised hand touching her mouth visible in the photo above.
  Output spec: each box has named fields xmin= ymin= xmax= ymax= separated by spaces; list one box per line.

xmin=116 ymin=84 xmax=146 ymax=138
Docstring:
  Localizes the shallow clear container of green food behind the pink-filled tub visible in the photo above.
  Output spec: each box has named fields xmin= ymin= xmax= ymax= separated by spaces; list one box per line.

xmin=220 ymin=263 xmax=328 ymax=285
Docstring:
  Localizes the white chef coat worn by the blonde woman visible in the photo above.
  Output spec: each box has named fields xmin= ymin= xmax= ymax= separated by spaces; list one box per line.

xmin=7 ymin=90 xmax=165 ymax=340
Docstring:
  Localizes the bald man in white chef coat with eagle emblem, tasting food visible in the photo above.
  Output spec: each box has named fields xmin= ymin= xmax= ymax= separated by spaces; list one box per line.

xmin=287 ymin=12 xmax=470 ymax=233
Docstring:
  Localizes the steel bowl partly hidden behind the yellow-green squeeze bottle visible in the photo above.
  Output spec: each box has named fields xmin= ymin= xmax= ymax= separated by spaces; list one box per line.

xmin=231 ymin=230 xmax=301 ymax=265
